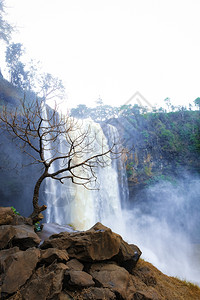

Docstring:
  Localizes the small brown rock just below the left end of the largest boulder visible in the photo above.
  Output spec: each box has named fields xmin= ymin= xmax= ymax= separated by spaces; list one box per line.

xmin=39 ymin=248 xmax=69 ymax=265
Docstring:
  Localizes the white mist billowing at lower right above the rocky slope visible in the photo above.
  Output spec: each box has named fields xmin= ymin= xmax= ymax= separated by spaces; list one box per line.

xmin=103 ymin=172 xmax=200 ymax=285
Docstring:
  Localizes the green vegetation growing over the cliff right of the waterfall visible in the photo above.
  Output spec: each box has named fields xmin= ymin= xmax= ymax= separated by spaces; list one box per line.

xmin=125 ymin=110 xmax=200 ymax=183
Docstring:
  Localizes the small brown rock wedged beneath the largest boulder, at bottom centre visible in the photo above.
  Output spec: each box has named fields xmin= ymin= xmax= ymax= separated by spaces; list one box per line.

xmin=63 ymin=270 xmax=95 ymax=289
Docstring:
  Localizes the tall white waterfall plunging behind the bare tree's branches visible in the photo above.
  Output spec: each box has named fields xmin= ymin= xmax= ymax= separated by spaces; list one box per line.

xmin=45 ymin=109 xmax=128 ymax=230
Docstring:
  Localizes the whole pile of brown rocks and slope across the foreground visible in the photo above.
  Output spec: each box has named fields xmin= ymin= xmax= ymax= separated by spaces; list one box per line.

xmin=0 ymin=208 xmax=200 ymax=300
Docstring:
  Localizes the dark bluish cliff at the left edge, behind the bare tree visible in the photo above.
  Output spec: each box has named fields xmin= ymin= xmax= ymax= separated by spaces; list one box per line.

xmin=0 ymin=77 xmax=45 ymax=215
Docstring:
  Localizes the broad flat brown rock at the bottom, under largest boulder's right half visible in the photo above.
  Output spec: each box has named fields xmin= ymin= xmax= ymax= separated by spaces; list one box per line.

xmin=89 ymin=263 xmax=136 ymax=299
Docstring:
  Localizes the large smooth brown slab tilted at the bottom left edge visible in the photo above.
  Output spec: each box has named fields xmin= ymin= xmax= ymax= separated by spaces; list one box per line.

xmin=0 ymin=247 xmax=40 ymax=294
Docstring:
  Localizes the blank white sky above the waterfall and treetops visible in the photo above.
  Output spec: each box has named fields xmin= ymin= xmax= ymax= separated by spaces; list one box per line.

xmin=1 ymin=0 xmax=200 ymax=106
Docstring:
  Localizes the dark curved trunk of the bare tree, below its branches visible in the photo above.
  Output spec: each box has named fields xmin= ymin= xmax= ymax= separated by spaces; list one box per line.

xmin=29 ymin=170 xmax=48 ymax=224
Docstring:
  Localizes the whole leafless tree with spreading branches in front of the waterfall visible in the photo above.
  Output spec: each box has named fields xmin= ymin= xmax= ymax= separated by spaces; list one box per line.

xmin=0 ymin=99 xmax=120 ymax=223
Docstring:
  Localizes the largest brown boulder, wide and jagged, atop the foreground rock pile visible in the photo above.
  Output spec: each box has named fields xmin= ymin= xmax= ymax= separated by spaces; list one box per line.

xmin=41 ymin=223 xmax=141 ymax=270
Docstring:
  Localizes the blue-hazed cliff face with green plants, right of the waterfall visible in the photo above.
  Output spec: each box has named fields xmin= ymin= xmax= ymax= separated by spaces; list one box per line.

xmin=111 ymin=111 xmax=200 ymax=197
